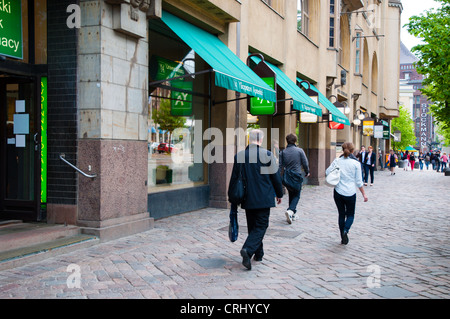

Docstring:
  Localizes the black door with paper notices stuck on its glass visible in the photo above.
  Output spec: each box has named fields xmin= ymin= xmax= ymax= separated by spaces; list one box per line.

xmin=0 ymin=76 xmax=41 ymax=221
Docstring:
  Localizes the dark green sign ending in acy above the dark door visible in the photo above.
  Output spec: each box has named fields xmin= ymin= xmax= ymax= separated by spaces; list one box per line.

xmin=0 ymin=0 xmax=23 ymax=59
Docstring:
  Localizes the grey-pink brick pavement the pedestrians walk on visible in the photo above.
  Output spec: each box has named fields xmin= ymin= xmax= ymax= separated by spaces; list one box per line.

xmin=0 ymin=169 xmax=450 ymax=299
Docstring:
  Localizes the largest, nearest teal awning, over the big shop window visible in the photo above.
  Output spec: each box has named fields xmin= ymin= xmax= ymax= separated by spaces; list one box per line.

xmin=162 ymin=11 xmax=277 ymax=102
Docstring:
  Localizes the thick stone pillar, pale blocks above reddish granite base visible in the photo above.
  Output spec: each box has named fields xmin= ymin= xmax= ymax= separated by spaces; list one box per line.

xmin=77 ymin=0 xmax=153 ymax=240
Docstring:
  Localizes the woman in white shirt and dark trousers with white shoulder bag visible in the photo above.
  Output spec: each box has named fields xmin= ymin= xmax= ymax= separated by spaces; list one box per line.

xmin=326 ymin=142 xmax=368 ymax=245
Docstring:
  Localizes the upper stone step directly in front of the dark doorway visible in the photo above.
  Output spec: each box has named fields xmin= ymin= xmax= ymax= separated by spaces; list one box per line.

xmin=0 ymin=222 xmax=81 ymax=253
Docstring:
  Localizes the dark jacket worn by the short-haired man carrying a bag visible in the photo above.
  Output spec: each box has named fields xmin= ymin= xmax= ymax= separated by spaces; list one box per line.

xmin=230 ymin=144 xmax=283 ymax=209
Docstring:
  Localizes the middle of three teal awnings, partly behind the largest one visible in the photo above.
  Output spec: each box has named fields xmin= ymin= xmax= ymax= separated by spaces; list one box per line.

xmin=251 ymin=56 xmax=322 ymax=116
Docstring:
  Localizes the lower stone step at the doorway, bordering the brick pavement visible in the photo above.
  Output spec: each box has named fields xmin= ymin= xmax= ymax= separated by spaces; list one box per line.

xmin=0 ymin=234 xmax=100 ymax=270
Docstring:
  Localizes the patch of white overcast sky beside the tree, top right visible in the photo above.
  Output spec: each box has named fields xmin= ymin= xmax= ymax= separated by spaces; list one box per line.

xmin=400 ymin=0 xmax=440 ymax=50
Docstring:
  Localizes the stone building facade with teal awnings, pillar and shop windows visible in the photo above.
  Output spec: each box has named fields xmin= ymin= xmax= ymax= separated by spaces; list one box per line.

xmin=0 ymin=0 xmax=402 ymax=239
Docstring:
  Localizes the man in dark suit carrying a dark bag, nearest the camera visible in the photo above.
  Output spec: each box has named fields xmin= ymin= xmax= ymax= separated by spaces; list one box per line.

xmin=230 ymin=129 xmax=283 ymax=270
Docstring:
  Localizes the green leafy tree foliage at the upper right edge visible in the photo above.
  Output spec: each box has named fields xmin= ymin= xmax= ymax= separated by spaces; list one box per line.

xmin=406 ymin=0 xmax=450 ymax=131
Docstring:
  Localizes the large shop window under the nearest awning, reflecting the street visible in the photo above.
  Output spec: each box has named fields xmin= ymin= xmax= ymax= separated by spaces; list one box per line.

xmin=148 ymin=22 xmax=209 ymax=193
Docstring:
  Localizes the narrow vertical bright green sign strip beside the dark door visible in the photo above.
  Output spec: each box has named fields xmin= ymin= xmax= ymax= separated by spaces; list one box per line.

xmin=41 ymin=77 xmax=47 ymax=203
